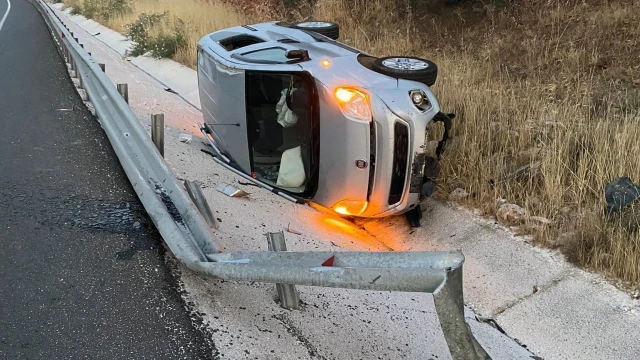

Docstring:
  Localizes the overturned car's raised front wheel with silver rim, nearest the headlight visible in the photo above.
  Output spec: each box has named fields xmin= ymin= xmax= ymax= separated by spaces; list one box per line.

xmin=373 ymin=56 xmax=438 ymax=86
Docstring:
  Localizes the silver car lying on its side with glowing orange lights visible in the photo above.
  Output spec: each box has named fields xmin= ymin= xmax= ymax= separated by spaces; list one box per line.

xmin=198 ymin=22 xmax=446 ymax=224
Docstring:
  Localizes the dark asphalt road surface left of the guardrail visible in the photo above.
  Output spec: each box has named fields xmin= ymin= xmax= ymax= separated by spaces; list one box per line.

xmin=0 ymin=0 xmax=217 ymax=359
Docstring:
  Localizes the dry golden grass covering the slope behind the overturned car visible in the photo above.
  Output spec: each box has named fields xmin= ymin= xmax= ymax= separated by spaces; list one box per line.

xmin=61 ymin=0 xmax=640 ymax=283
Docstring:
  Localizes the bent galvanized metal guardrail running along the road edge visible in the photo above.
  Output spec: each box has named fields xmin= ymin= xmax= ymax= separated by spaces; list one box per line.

xmin=30 ymin=0 xmax=490 ymax=360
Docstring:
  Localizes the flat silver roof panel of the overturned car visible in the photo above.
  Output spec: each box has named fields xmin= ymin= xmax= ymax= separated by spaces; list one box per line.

xmin=198 ymin=48 xmax=251 ymax=173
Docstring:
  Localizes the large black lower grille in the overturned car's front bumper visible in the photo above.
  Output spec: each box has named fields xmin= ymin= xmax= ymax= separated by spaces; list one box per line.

xmin=389 ymin=123 xmax=409 ymax=205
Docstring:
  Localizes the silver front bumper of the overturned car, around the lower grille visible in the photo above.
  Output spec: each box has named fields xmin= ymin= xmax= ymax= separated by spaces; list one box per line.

xmin=360 ymin=83 xmax=439 ymax=217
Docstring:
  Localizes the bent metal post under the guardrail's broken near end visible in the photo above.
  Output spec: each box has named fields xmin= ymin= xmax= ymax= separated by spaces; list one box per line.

xmin=433 ymin=266 xmax=491 ymax=360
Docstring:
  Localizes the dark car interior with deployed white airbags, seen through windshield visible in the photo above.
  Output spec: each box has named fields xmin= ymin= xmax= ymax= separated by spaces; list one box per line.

xmin=246 ymin=72 xmax=312 ymax=193
